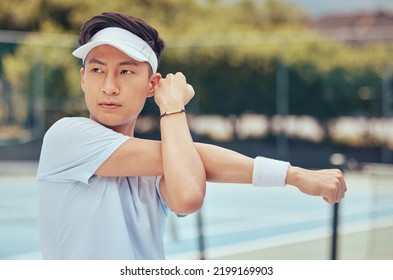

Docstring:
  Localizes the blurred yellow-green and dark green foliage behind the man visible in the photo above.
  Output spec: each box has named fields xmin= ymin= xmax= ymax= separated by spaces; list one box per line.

xmin=0 ymin=0 xmax=393 ymax=129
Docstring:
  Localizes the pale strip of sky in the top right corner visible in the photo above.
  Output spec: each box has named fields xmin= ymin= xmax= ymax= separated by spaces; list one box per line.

xmin=286 ymin=0 xmax=393 ymax=17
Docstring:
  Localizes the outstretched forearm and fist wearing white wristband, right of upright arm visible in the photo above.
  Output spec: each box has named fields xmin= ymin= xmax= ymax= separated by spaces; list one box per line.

xmin=195 ymin=143 xmax=347 ymax=204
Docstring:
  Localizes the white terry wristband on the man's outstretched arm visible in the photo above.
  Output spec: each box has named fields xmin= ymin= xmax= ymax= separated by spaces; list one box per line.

xmin=252 ymin=157 xmax=291 ymax=187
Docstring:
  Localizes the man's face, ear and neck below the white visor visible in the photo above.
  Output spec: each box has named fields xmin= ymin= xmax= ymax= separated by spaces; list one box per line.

xmin=81 ymin=45 xmax=157 ymax=134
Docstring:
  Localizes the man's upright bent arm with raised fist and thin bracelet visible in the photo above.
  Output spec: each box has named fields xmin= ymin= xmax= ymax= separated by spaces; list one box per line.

xmin=155 ymin=73 xmax=206 ymax=214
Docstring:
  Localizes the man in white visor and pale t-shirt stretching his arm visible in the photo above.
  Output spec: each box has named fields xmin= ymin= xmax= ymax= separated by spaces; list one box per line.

xmin=37 ymin=13 xmax=346 ymax=259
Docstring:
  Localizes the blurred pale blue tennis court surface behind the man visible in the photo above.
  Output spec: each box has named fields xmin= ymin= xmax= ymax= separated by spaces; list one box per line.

xmin=0 ymin=167 xmax=393 ymax=260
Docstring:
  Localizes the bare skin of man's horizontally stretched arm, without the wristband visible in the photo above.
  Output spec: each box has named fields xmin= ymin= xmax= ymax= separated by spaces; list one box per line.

xmin=100 ymin=139 xmax=347 ymax=204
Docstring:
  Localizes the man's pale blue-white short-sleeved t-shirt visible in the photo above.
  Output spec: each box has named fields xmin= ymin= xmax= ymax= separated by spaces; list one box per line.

xmin=37 ymin=117 xmax=168 ymax=259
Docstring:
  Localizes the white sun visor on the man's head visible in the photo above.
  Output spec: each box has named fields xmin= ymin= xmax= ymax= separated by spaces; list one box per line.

xmin=72 ymin=27 xmax=158 ymax=73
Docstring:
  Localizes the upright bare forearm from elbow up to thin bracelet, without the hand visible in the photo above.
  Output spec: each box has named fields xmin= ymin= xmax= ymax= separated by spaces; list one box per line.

xmin=160 ymin=113 xmax=206 ymax=213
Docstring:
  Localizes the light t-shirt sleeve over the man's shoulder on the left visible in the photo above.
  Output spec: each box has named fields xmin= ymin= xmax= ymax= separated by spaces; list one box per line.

xmin=37 ymin=118 xmax=130 ymax=184
